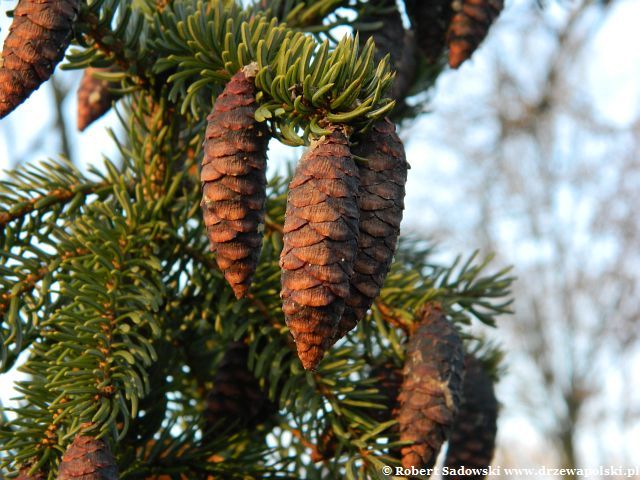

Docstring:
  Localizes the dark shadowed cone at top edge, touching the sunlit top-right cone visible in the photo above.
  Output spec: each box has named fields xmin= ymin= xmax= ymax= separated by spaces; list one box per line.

xmin=405 ymin=0 xmax=453 ymax=63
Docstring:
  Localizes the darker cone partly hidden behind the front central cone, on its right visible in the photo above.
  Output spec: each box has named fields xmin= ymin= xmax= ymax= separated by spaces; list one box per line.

xmin=335 ymin=119 xmax=409 ymax=341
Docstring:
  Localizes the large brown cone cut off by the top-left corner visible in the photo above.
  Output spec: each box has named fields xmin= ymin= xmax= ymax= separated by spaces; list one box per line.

xmin=0 ymin=0 xmax=80 ymax=118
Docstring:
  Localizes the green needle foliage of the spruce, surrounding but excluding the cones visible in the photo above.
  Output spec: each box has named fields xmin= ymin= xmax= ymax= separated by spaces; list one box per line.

xmin=0 ymin=0 xmax=512 ymax=480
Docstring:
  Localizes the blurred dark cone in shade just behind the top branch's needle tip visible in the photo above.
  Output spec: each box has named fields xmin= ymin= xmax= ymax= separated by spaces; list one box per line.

xmin=359 ymin=0 xmax=416 ymax=100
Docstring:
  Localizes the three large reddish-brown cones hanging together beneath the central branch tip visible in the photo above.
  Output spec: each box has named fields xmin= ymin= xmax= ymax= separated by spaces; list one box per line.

xmin=201 ymin=66 xmax=408 ymax=369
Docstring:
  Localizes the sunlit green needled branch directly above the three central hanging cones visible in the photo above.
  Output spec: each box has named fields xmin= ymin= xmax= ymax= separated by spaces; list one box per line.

xmin=154 ymin=0 xmax=394 ymax=145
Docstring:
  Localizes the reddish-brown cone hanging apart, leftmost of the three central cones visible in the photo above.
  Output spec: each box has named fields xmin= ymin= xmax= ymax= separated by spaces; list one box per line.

xmin=200 ymin=67 xmax=269 ymax=298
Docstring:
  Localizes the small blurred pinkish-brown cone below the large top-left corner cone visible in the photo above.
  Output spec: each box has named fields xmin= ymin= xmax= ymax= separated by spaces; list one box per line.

xmin=78 ymin=67 xmax=117 ymax=132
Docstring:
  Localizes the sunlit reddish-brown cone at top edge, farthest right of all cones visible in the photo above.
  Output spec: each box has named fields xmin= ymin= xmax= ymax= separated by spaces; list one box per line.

xmin=447 ymin=0 xmax=504 ymax=68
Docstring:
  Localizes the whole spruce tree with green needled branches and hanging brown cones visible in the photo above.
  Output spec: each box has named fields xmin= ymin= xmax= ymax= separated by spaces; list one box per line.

xmin=0 ymin=0 xmax=512 ymax=480
